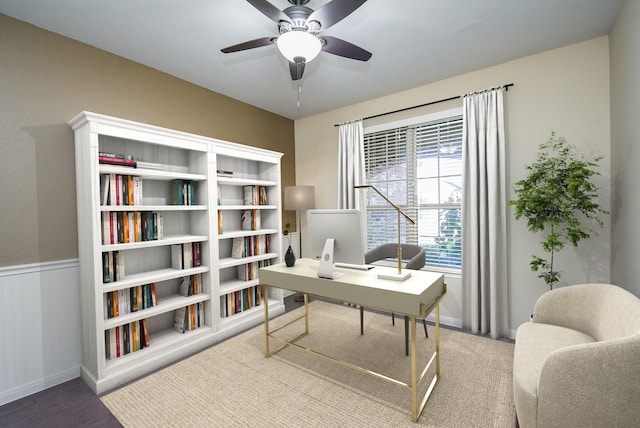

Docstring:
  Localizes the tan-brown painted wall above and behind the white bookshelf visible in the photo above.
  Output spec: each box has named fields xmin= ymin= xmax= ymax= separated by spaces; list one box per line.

xmin=0 ymin=14 xmax=295 ymax=266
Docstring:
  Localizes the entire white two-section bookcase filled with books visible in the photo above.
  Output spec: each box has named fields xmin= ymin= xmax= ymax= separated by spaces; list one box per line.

xmin=69 ymin=112 xmax=284 ymax=393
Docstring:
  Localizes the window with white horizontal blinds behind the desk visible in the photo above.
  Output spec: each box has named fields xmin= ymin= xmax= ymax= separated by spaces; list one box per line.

xmin=364 ymin=109 xmax=462 ymax=270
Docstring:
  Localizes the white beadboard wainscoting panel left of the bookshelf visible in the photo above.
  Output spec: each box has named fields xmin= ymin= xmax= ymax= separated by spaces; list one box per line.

xmin=0 ymin=259 xmax=82 ymax=405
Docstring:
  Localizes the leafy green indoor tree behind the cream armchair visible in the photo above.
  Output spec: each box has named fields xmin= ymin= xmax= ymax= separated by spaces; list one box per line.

xmin=509 ymin=131 xmax=608 ymax=289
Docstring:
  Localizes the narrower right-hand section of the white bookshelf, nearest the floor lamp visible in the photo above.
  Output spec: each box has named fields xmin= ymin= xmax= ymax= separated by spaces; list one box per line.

xmin=214 ymin=144 xmax=284 ymax=324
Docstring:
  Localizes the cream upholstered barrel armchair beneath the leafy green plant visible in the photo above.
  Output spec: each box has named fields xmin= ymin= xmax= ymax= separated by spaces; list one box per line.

xmin=513 ymin=284 xmax=640 ymax=428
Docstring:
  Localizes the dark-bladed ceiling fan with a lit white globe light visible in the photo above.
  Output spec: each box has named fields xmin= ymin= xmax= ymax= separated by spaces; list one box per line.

xmin=221 ymin=0 xmax=372 ymax=80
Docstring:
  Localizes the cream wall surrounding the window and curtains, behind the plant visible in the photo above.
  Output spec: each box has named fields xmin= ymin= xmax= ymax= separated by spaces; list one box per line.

xmin=295 ymin=37 xmax=610 ymax=329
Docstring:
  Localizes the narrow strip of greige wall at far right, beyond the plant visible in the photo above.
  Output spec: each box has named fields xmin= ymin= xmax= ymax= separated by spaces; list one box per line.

xmin=610 ymin=0 xmax=640 ymax=296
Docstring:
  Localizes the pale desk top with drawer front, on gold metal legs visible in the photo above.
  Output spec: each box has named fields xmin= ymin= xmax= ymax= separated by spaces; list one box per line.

xmin=259 ymin=258 xmax=445 ymax=318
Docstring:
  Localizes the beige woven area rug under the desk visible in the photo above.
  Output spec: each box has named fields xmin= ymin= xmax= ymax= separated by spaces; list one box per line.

xmin=102 ymin=301 xmax=515 ymax=427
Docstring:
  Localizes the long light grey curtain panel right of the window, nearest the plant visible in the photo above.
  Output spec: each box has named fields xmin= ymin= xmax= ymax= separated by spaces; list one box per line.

xmin=462 ymin=88 xmax=508 ymax=339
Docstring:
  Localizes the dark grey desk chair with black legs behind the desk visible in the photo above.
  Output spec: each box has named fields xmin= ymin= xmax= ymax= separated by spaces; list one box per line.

xmin=360 ymin=244 xmax=429 ymax=355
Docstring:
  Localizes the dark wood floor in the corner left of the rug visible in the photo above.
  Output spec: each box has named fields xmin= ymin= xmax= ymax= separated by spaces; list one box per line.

xmin=0 ymin=296 xmax=301 ymax=428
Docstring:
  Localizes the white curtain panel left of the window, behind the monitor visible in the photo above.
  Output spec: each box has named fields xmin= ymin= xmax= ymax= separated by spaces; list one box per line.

xmin=338 ymin=119 xmax=367 ymax=248
